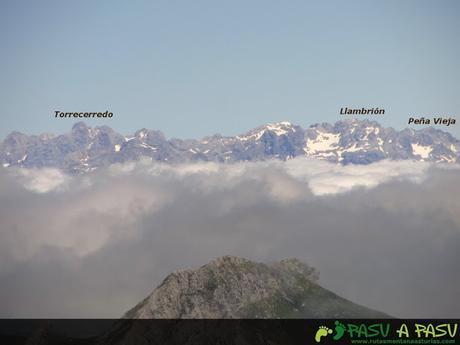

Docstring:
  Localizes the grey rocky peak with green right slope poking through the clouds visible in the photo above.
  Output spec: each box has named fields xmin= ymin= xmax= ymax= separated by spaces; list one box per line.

xmin=124 ymin=256 xmax=388 ymax=319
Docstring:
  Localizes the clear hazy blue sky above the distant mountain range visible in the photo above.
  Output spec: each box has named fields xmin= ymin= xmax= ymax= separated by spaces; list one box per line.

xmin=0 ymin=0 xmax=460 ymax=137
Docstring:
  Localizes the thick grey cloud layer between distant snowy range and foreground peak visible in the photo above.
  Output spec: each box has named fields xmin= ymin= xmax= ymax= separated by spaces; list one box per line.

xmin=0 ymin=158 xmax=460 ymax=318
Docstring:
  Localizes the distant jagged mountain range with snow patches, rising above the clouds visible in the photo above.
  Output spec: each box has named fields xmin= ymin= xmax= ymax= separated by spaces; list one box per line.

xmin=0 ymin=120 xmax=460 ymax=174
